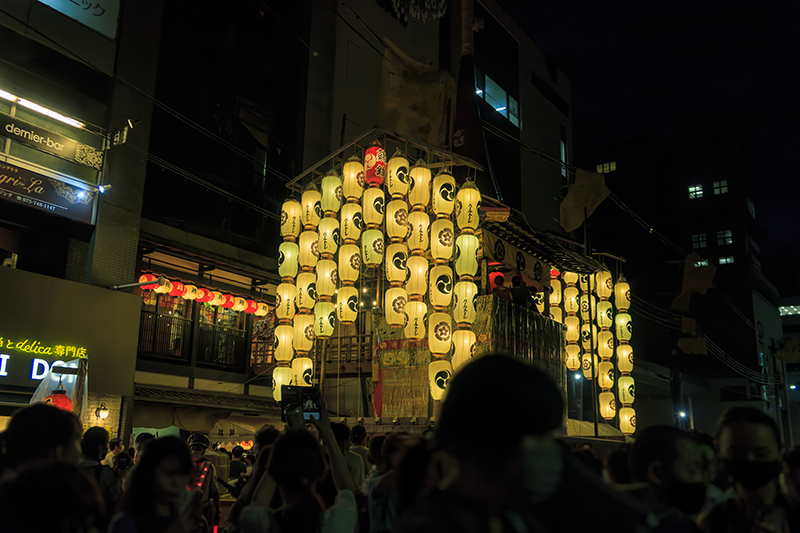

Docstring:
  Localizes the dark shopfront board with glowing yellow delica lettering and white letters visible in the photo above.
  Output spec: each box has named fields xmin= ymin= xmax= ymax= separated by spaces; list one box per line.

xmin=0 ymin=268 xmax=142 ymax=396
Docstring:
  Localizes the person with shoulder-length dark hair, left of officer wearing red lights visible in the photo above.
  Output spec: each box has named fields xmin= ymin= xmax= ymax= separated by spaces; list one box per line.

xmin=108 ymin=437 xmax=208 ymax=533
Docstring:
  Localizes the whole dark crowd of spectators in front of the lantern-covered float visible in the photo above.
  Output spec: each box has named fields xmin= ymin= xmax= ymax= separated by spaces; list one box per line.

xmin=0 ymin=355 xmax=800 ymax=533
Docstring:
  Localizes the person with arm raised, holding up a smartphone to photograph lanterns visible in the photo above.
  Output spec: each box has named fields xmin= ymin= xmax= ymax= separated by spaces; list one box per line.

xmin=239 ymin=394 xmax=358 ymax=533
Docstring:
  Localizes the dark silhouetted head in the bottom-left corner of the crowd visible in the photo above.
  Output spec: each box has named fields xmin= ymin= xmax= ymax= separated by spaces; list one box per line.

xmin=0 ymin=460 xmax=105 ymax=533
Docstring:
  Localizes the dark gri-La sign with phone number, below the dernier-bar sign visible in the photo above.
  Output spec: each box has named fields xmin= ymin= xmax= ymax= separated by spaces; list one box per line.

xmin=0 ymin=163 xmax=96 ymax=224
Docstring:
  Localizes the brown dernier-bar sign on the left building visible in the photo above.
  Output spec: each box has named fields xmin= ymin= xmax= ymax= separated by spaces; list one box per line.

xmin=0 ymin=113 xmax=103 ymax=170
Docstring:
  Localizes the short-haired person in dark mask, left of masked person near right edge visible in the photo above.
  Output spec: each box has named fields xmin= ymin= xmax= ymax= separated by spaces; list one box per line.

xmin=630 ymin=425 xmax=706 ymax=533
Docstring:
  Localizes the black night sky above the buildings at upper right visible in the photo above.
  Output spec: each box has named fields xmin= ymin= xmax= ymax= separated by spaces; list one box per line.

xmin=500 ymin=0 xmax=800 ymax=264
